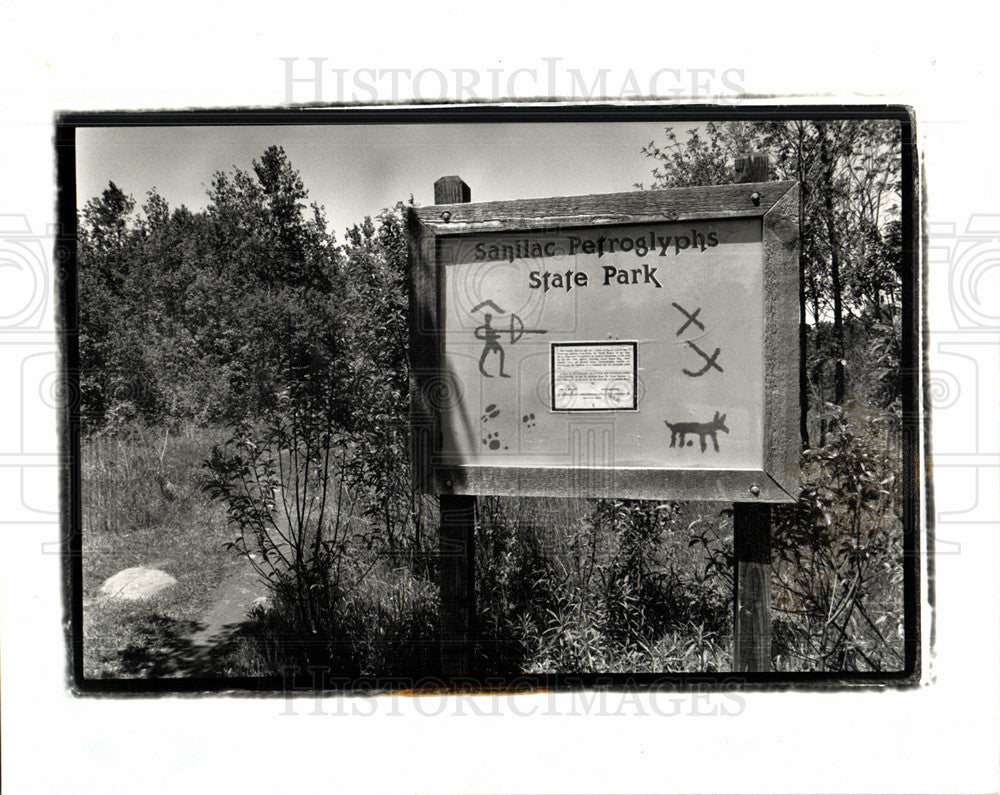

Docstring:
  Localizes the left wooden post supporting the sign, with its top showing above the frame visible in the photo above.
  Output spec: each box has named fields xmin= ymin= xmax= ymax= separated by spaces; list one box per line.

xmin=434 ymin=176 xmax=476 ymax=677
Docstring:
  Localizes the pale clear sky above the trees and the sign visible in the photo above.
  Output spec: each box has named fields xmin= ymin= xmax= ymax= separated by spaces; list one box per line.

xmin=77 ymin=122 xmax=700 ymax=240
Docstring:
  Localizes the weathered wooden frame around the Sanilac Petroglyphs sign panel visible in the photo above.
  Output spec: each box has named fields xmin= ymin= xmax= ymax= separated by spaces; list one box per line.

xmin=408 ymin=182 xmax=800 ymax=503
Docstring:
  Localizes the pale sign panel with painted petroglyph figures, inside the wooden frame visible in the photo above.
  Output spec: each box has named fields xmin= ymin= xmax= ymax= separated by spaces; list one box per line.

xmin=439 ymin=218 xmax=765 ymax=470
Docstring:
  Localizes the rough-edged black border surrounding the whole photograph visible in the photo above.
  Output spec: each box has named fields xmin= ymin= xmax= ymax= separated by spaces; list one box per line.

xmin=54 ymin=103 xmax=920 ymax=698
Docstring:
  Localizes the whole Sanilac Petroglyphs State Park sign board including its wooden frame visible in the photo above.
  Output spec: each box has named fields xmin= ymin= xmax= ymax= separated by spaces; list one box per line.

xmin=410 ymin=182 xmax=799 ymax=502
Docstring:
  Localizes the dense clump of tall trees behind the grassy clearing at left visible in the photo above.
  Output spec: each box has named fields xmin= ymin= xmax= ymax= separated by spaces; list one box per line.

xmin=79 ymin=146 xmax=348 ymax=430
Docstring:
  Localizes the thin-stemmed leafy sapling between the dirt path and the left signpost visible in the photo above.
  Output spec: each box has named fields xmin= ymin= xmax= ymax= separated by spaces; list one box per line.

xmin=205 ymin=291 xmax=361 ymax=654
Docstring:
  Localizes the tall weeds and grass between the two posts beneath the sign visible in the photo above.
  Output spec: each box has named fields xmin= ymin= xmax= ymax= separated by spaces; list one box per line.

xmin=477 ymin=498 xmax=731 ymax=673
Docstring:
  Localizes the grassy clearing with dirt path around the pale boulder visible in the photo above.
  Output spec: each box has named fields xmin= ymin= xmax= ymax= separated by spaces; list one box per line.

xmin=82 ymin=428 xmax=240 ymax=678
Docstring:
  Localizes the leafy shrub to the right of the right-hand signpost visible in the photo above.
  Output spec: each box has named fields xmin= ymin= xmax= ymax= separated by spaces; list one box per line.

xmin=773 ymin=405 xmax=903 ymax=671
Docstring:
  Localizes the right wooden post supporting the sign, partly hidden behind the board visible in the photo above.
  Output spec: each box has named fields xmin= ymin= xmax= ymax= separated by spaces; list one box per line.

xmin=733 ymin=152 xmax=771 ymax=672
